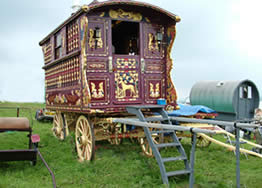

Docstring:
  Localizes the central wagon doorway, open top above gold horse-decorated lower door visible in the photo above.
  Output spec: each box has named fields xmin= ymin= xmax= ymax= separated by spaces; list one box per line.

xmin=109 ymin=20 xmax=142 ymax=104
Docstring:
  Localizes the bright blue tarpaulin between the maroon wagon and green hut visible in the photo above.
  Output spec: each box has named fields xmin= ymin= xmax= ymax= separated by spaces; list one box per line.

xmin=167 ymin=104 xmax=216 ymax=116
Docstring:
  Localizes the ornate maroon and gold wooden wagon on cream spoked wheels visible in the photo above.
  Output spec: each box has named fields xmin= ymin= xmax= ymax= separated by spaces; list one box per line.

xmin=39 ymin=0 xmax=180 ymax=161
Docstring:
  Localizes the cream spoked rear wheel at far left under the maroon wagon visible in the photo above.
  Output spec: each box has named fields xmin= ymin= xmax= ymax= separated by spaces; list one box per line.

xmin=52 ymin=112 xmax=69 ymax=140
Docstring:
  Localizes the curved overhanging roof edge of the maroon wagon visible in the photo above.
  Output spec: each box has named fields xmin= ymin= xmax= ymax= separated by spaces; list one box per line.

xmin=39 ymin=0 xmax=181 ymax=45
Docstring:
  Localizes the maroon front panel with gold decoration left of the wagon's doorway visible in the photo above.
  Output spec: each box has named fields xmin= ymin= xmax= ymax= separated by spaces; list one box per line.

xmin=86 ymin=18 xmax=110 ymax=107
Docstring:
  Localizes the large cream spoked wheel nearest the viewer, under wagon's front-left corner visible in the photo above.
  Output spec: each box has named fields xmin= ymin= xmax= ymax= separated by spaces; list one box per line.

xmin=75 ymin=116 xmax=95 ymax=162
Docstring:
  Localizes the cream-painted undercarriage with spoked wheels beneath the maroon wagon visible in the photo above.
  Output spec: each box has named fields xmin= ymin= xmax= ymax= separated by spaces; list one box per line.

xmin=52 ymin=112 xmax=165 ymax=161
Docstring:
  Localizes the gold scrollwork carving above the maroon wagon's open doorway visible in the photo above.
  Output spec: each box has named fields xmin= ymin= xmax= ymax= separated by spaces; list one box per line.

xmin=109 ymin=9 xmax=143 ymax=21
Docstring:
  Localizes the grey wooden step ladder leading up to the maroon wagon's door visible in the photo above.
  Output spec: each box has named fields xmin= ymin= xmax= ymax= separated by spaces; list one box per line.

xmin=126 ymin=105 xmax=196 ymax=187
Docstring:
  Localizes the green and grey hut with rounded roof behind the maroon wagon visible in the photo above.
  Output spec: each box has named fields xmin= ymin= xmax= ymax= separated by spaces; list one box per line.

xmin=190 ymin=80 xmax=259 ymax=120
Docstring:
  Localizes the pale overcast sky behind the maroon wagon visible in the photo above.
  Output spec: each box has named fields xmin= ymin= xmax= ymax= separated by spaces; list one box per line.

xmin=0 ymin=0 xmax=262 ymax=102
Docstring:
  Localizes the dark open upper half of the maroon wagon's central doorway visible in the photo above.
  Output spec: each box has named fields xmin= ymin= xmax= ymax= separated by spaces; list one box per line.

xmin=112 ymin=20 xmax=139 ymax=55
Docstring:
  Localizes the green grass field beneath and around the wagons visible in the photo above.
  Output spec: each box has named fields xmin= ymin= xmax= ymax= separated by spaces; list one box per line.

xmin=0 ymin=103 xmax=262 ymax=188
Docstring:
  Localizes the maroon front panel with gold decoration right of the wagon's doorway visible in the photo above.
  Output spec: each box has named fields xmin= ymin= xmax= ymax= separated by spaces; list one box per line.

xmin=141 ymin=23 xmax=165 ymax=104
